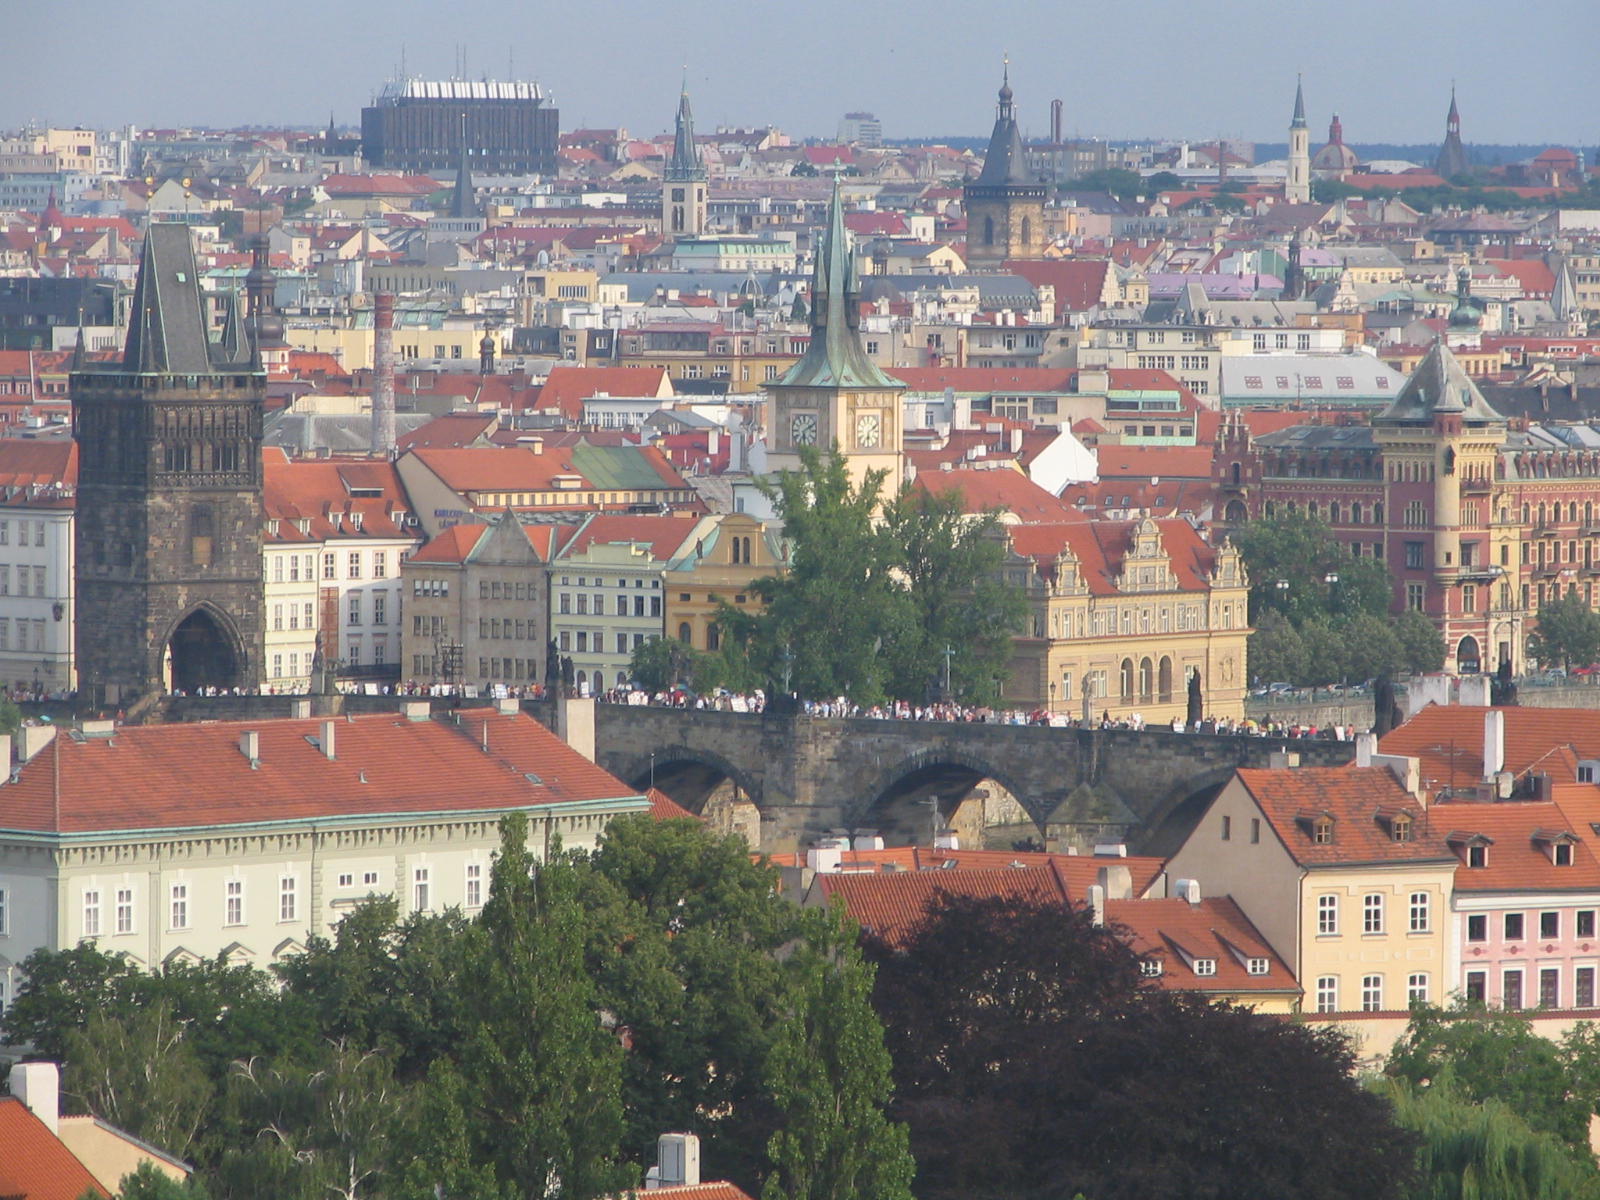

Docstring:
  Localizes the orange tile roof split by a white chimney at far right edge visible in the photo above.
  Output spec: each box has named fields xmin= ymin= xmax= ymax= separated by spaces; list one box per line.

xmin=1378 ymin=704 xmax=1600 ymax=790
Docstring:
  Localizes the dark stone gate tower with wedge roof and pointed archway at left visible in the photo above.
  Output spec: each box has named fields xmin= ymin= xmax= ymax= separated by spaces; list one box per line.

xmin=72 ymin=224 xmax=266 ymax=704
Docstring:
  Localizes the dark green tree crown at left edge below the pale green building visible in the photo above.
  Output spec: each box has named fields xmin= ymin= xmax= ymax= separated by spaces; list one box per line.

xmin=0 ymin=942 xmax=155 ymax=1062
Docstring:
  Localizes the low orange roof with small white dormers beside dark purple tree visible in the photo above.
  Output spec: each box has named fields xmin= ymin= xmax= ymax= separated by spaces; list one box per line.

xmin=1106 ymin=896 xmax=1301 ymax=995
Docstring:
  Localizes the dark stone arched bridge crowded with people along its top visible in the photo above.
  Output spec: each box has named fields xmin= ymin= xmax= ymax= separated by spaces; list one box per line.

xmin=582 ymin=704 xmax=1355 ymax=853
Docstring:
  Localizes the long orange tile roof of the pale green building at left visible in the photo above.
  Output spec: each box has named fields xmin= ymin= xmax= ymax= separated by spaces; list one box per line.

xmin=0 ymin=709 xmax=637 ymax=834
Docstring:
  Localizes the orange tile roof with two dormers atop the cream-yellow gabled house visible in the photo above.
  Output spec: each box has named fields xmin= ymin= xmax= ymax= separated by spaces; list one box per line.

xmin=1237 ymin=766 xmax=1456 ymax=867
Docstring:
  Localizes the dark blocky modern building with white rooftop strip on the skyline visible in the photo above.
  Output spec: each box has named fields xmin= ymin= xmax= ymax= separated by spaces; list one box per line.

xmin=362 ymin=78 xmax=560 ymax=178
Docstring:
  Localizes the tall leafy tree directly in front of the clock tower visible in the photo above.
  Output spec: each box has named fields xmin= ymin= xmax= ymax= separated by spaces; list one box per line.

xmin=718 ymin=446 xmax=912 ymax=704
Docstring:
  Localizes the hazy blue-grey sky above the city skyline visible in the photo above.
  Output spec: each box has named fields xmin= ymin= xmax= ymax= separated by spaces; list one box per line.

xmin=0 ymin=0 xmax=1600 ymax=147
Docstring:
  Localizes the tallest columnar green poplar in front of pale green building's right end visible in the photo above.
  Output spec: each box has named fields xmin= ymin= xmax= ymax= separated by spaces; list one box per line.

xmin=459 ymin=813 xmax=632 ymax=1200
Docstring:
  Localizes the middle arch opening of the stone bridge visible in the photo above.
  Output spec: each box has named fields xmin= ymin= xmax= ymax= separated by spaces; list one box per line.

xmin=846 ymin=746 xmax=1045 ymax=850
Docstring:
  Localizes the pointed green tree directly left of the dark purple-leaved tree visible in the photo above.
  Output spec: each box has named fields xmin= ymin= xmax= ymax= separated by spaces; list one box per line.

xmin=762 ymin=912 xmax=915 ymax=1200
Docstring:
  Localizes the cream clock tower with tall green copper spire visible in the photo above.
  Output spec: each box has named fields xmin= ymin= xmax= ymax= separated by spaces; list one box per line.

xmin=766 ymin=176 xmax=906 ymax=498
